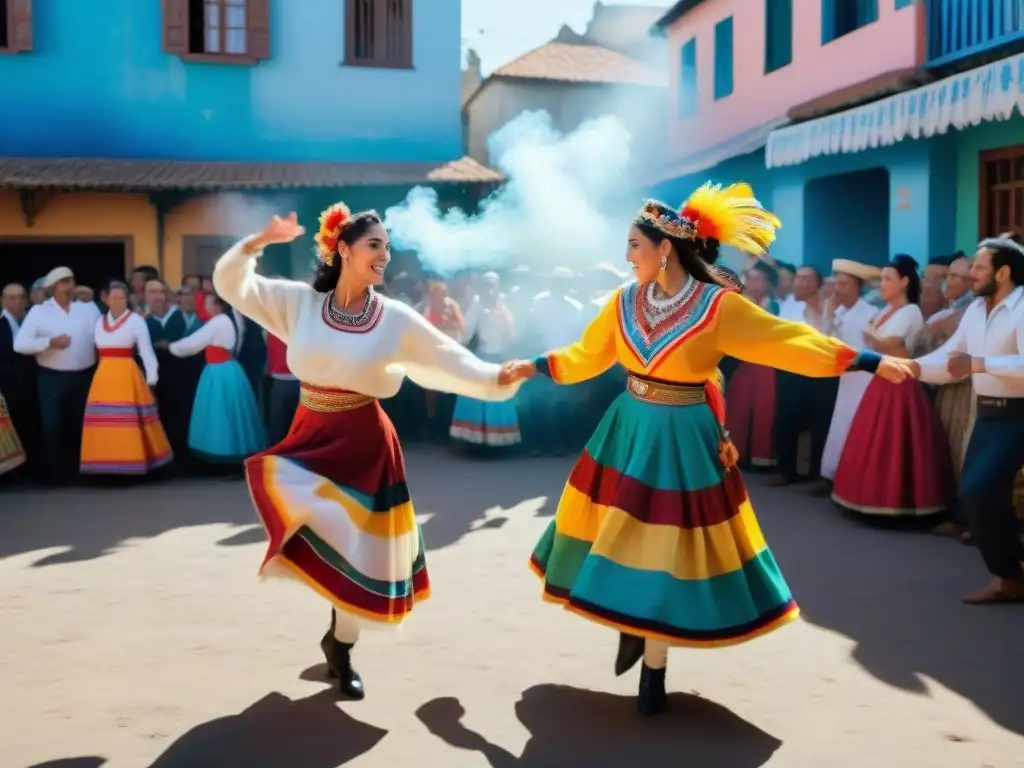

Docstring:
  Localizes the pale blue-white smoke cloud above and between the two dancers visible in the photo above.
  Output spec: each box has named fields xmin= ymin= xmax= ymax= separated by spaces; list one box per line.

xmin=384 ymin=112 xmax=639 ymax=274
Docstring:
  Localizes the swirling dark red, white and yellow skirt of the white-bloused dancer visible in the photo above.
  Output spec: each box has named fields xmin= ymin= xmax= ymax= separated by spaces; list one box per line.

xmin=246 ymin=384 xmax=430 ymax=624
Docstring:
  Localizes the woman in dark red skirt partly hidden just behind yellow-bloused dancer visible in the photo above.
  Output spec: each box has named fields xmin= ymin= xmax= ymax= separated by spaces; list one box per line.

xmin=725 ymin=260 xmax=778 ymax=467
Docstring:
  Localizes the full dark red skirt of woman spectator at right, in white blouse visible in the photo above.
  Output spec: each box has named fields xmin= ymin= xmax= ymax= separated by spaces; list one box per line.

xmin=833 ymin=378 xmax=955 ymax=517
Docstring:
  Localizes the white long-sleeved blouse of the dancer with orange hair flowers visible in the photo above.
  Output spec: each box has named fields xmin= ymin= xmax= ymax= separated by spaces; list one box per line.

xmin=214 ymin=241 xmax=518 ymax=401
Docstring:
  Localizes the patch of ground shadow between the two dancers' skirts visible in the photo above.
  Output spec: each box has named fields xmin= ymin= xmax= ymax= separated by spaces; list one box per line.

xmin=406 ymin=446 xmax=573 ymax=552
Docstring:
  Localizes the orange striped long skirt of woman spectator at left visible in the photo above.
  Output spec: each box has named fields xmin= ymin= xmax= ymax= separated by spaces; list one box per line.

xmin=80 ymin=347 xmax=173 ymax=475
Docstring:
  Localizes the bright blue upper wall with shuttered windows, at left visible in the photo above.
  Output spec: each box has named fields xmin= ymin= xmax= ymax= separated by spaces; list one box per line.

xmin=0 ymin=0 xmax=462 ymax=162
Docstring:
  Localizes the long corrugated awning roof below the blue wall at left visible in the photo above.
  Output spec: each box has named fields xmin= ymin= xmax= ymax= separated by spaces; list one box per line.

xmin=0 ymin=157 xmax=505 ymax=191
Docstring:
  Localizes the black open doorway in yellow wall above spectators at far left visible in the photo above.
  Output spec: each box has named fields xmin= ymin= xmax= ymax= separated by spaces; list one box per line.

xmin=0 ymin=239 xmax=128 ymax=295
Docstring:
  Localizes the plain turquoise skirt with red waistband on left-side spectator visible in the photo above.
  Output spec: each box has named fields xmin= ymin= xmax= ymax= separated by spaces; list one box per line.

xmin=188 ymin=347 xmax=266 ymax=464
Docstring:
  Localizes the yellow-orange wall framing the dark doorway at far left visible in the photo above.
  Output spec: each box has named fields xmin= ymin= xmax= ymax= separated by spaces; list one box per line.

xmin=0 ymin=189 xmax=157 ymax=272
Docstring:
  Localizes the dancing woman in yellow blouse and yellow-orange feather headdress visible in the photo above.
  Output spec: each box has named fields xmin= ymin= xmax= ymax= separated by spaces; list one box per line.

xmin=499 ymin=184 xmax=908 ymax=714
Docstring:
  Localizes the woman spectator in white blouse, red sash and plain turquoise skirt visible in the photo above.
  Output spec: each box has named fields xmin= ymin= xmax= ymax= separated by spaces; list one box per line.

xmin=169 ymin=296 xmax=266 ymax=466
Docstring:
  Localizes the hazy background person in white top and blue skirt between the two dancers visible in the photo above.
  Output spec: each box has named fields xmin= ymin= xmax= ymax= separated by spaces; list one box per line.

xmin=449 ymin=272 xmax=521 ymax=449
